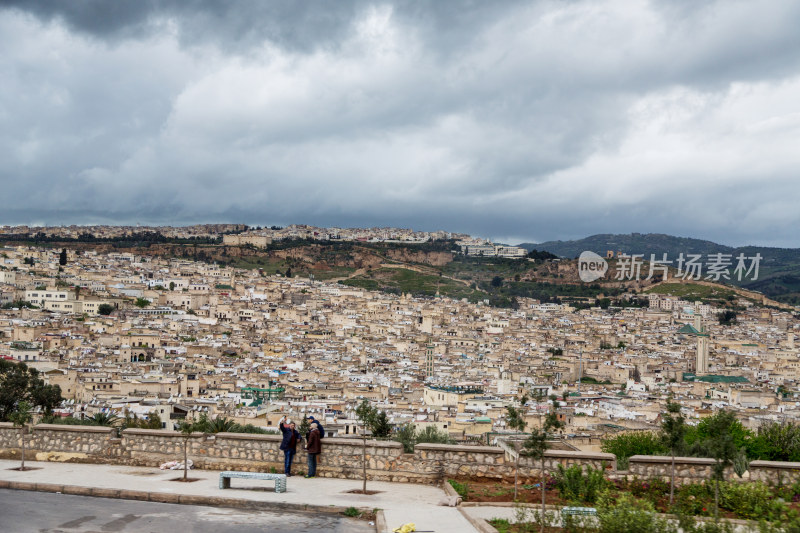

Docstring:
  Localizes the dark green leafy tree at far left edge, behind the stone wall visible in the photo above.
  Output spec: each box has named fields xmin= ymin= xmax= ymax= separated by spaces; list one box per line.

xmin=0 ymin=359 xmax=63 ymax=420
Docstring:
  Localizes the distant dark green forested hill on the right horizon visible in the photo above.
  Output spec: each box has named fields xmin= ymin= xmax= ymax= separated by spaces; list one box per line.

xmin=520 ymin=233 xmax=800 ymax=305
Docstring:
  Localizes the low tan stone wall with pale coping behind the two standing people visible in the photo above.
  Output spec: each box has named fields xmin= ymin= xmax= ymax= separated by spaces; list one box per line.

xmin=0 ymin=423 xmax=800 ymax=483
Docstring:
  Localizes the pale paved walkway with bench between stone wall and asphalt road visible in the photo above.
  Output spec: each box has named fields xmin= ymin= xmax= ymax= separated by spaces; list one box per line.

xmin=0 ymin=460 xmax=476 ymax=533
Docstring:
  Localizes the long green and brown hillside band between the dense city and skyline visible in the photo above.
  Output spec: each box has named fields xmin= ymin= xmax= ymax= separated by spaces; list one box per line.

xmin=6 ymin=234 xmax=800 ymax=307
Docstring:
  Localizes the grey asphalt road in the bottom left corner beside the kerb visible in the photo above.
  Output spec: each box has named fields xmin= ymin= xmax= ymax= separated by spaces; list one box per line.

xmin=0 ymin=489 xmax=375 ymax=533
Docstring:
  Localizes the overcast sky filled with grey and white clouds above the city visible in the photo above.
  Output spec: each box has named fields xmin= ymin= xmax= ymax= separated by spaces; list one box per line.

xmin=0 ymin=0 xmax=800 ymax=247
